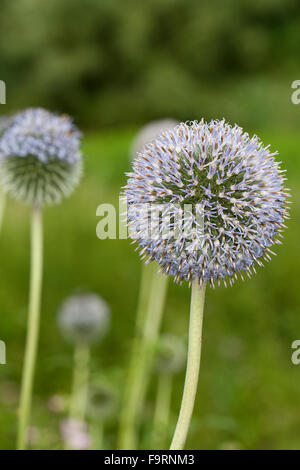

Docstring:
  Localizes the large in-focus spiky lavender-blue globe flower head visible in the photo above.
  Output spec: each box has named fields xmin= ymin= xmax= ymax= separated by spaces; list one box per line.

xmin=124 ymin=120 xmax=288 ymax=286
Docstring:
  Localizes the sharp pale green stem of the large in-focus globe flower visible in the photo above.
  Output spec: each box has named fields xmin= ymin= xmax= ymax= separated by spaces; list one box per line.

xmin=170 ymin=281 xmax=205 ymax=450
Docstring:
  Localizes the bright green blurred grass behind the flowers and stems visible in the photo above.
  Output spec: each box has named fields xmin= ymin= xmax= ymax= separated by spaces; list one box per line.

xmin=0 ymin=126 xmax=300 ymax=449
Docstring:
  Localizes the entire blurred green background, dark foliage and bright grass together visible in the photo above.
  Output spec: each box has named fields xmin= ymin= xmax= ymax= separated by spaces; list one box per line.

xmin=0 ymin=0 xmax=300 ymax=449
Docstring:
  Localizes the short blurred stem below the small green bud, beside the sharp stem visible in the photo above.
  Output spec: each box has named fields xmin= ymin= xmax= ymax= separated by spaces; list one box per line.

xmin=152 ymin=374 xmax=172 ymax=450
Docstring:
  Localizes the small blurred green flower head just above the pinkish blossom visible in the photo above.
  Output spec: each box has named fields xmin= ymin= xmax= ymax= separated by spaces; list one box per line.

xmin=88 ymin=380 xmax=117 ymax=420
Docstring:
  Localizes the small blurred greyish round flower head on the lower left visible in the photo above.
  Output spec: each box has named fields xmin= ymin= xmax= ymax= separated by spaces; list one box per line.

xmin=58 ymin=293 xmax=110 ymax=344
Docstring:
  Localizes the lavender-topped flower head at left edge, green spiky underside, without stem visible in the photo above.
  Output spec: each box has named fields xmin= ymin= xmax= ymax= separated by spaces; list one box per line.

xmin=0 ymin=108 xmax=82 ymax=206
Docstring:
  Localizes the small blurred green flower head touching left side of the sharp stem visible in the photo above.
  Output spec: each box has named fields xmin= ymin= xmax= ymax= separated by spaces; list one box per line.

xmin=155 ymin=335 xmax=186 ymax=374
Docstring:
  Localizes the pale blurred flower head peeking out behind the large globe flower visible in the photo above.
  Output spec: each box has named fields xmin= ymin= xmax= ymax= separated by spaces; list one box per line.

xmin=130 ymin=119 xmax=179 ymax=160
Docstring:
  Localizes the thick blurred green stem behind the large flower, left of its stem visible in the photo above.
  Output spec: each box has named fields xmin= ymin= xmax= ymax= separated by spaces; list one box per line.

xmin=119 ymin=263 xmax=168 ymax=450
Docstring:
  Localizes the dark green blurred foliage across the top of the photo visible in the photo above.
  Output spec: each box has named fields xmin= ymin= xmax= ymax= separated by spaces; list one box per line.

xmin=0 ymin=0 xmax=300 ymax=128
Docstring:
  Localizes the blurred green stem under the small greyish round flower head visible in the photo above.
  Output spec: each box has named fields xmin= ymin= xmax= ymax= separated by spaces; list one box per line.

xmin=70 ymin=344 xmax=90 ymax=421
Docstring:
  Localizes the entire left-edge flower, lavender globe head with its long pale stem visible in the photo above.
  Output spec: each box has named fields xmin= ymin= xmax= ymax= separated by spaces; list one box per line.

xmin=10 ymin=108 xmax=82 ymax=450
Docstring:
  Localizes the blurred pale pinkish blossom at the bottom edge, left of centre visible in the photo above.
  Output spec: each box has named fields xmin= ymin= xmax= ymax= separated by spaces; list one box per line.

xmin=60 ymin=419 xmax=91 ymax=450
